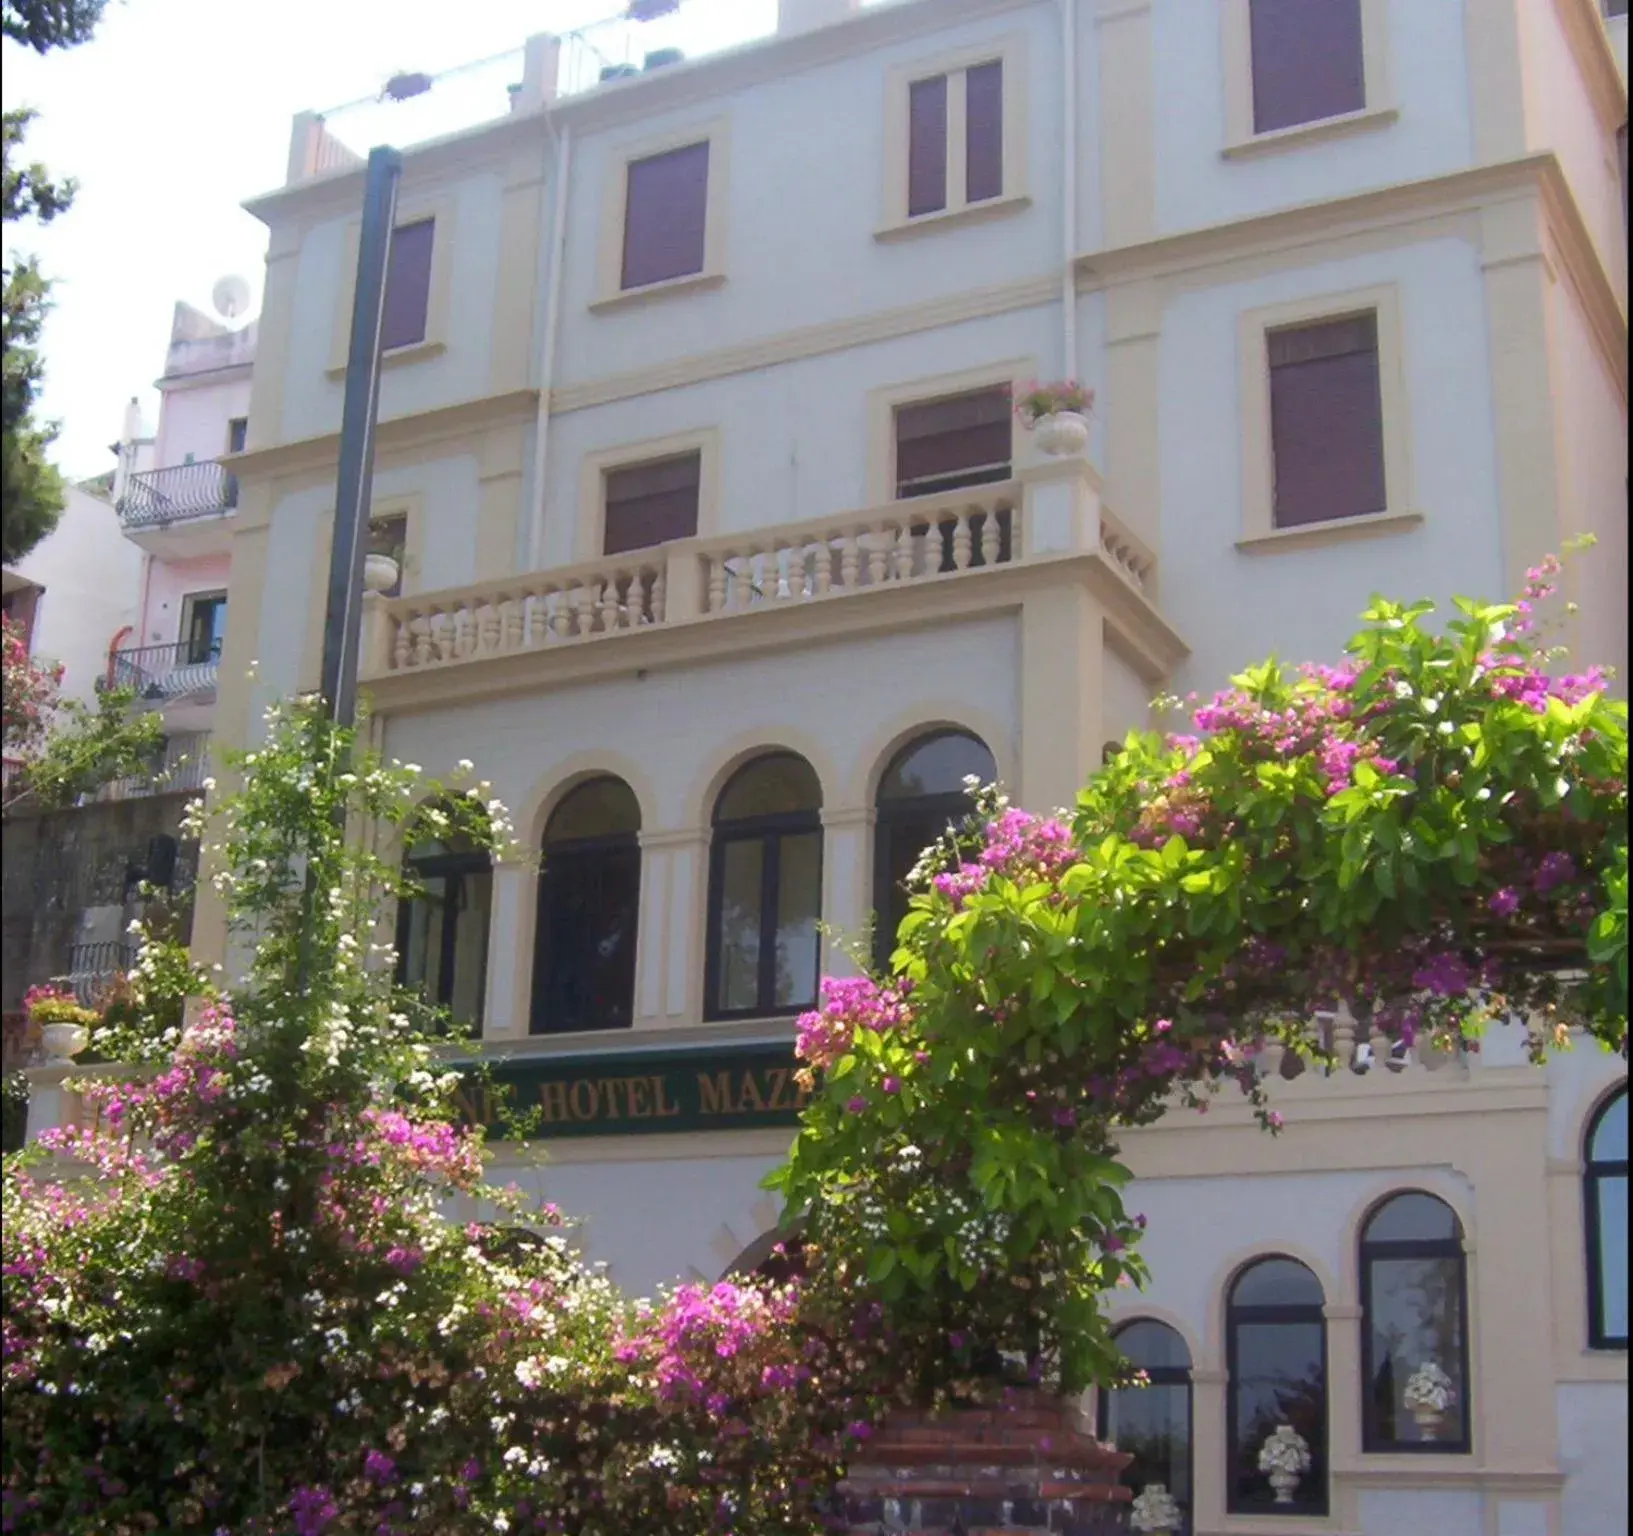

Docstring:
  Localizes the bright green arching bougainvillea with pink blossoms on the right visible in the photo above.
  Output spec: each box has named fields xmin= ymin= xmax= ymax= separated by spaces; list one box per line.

xmin=772 ymin=560 xmax=1628 ymax=1396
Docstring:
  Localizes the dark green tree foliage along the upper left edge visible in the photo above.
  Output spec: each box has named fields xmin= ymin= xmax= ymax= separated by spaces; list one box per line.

xmin=0 ymin=0 xmax=106 ymax=565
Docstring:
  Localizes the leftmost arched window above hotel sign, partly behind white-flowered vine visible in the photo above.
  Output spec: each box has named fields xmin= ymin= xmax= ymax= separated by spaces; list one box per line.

xmin=397 ymin=822 xmax=493 ymax=1028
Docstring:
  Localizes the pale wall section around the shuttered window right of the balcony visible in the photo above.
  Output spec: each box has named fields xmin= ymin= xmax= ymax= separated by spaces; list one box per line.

xmin=1158 ymin=240 xmax=1507 ymax=694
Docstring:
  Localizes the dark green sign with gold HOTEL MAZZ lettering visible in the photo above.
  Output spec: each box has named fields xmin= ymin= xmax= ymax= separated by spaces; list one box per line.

xmin=459 ymin=1043 xmax=805 ymax=1139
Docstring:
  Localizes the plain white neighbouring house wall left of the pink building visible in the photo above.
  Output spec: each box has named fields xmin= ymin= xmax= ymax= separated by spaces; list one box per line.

xmin=11 ymin=485 xmax=142 ymax=704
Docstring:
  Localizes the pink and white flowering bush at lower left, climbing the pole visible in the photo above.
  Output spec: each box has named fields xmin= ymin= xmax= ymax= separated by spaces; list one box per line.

xmin=0 ymin=707 xmax=869 ymax=1536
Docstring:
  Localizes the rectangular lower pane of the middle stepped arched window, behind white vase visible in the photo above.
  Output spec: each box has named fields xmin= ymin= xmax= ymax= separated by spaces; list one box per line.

xmin=1231 ymin=1318 xmax=1326 ymax=1508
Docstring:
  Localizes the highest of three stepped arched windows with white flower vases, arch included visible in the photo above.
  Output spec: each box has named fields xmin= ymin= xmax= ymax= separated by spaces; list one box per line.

xmin=1360 ymin=1190 xmax=1470 ymax=1451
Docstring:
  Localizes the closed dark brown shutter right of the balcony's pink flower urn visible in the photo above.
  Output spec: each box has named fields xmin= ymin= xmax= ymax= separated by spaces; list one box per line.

xmin=1266 ymin=315 xmax=1388 ymax=527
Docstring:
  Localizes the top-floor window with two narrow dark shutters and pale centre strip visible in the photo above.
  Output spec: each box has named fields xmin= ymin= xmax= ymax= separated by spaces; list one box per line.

xmin=908 ymin=59 xmax=1004 ymax=219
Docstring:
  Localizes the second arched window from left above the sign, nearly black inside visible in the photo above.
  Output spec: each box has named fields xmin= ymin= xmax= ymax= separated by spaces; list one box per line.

xmin=531 ymin=774 xmax=640 ymax=1035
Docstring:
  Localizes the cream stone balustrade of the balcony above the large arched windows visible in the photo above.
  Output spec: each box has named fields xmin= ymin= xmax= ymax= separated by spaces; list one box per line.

xmin=363 ymin=465 xmax=1177 ymax=679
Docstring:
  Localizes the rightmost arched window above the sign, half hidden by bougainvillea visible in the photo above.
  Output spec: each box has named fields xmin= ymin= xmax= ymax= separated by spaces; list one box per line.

xmin=874 ymin=731 xmax=998 ymax=968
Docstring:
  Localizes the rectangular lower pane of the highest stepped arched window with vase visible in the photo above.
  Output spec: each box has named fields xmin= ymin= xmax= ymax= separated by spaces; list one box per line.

xmin=1367 ymin=1259 xmax=1466 ymax=1445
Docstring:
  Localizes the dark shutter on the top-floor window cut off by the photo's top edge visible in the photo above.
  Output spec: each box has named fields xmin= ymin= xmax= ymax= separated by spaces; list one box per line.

xmin=1249 ymin=0 xmax=1367 ymax=134
